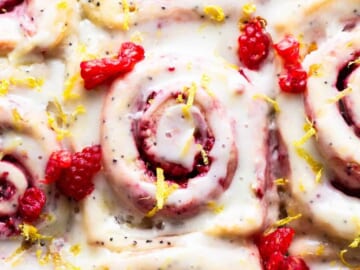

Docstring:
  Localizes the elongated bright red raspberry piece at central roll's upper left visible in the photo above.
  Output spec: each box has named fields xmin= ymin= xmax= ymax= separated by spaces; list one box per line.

xmin=80 ymin=42 xmax=145 ymax=90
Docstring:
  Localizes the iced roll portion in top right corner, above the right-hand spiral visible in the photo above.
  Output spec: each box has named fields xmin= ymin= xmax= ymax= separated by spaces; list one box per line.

xmin=267 ymin=0 xmax=359 ymax=50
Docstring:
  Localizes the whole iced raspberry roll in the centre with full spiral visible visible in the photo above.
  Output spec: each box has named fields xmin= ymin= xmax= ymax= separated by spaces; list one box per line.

xmin=84 ymin=51 xmax=269 ymax=269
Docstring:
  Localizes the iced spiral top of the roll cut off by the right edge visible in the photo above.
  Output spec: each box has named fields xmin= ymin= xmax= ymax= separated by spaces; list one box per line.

xmin=305 ymin=28 xmax=360 ymax=192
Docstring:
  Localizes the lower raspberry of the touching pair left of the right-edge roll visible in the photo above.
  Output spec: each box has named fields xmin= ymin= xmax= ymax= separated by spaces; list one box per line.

xmin=279 ymin=65 xmax=307 ymax=94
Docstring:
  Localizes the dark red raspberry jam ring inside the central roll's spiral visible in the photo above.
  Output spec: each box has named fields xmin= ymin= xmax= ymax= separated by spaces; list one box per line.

xmin=133 ymin=92 xmax=215 ymax=187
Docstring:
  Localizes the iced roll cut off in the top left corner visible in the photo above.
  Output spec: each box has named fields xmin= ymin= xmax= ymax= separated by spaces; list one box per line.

xmin=0 ymin=0 xmax=74 ymax=54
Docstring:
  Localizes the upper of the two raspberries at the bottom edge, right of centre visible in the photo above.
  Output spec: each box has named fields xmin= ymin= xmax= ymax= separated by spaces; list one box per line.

xmin=257 ymin=227 xmax=295 ymax=261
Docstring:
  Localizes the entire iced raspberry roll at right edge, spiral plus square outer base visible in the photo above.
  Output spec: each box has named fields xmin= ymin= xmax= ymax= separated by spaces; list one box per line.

xmin=277 ymin=29 xmax=360 ymax=260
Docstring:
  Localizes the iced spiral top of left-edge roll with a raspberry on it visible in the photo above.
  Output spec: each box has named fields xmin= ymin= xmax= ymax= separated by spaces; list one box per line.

xmin=0 ymin=95 xmax=60 ymax=237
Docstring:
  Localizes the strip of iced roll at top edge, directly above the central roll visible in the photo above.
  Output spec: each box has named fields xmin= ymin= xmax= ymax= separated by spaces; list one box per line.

xmin=80 ymin=0 xmax=245 ymax=31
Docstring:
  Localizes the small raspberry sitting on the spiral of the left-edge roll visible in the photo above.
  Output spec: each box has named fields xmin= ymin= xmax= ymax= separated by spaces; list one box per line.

xmin=18 ymin=187 xmax=46 ymax=222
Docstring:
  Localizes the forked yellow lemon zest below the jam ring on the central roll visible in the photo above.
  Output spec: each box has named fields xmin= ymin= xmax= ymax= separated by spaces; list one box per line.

xmin=146 ymin=168 xmax=179 ymax=217
